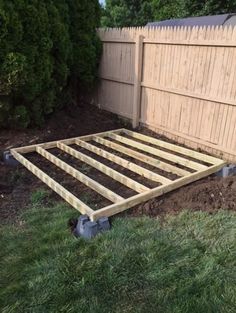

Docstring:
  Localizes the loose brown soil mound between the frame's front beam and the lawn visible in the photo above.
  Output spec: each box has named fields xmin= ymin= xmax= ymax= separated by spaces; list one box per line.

xmin=126 ymin=176 xmax=236 ymax=217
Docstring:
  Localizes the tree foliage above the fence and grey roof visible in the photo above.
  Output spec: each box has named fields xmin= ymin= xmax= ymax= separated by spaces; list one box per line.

xmin=102 ymin=0 xmax=236 ymax=27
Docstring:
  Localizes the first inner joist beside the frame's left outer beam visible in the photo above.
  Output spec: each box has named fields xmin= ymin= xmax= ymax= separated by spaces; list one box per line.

xmin=36 ymin=147 xmax=124 ymax=202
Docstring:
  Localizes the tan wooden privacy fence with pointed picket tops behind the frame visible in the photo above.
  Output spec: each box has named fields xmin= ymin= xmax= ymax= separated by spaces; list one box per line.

xmin=91 ymin=27 xmax=236 ymax=162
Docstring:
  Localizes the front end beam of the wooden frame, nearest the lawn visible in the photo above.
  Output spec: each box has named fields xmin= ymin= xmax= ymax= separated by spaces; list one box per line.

xmin=91 ymin=162 xmax=225 ymax=221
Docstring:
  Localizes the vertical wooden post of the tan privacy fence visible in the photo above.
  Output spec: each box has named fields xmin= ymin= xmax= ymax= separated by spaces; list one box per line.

xmin=132 ymin=35 xmax=144 ymax=128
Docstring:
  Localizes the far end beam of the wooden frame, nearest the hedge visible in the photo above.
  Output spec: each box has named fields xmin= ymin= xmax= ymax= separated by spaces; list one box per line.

xmin=11 ymin=128 xmax=123 ymax=153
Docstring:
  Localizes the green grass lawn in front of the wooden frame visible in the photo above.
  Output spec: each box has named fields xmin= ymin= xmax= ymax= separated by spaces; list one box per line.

xmin=0 ymin=190 xmax=236 ymax=313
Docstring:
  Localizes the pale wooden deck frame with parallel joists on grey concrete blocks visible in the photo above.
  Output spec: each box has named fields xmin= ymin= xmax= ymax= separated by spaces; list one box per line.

xmin=11 ymin=129 xmax=225 ymax=221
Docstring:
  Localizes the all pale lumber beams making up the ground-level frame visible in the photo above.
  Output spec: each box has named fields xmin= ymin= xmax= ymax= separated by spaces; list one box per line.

xmin=11 ymin=129 xmax=225 ymax=220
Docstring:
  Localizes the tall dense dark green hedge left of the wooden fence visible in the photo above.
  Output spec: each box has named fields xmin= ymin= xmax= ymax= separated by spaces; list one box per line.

xmin=0 ymin=0 xmax=100 ymax=127
